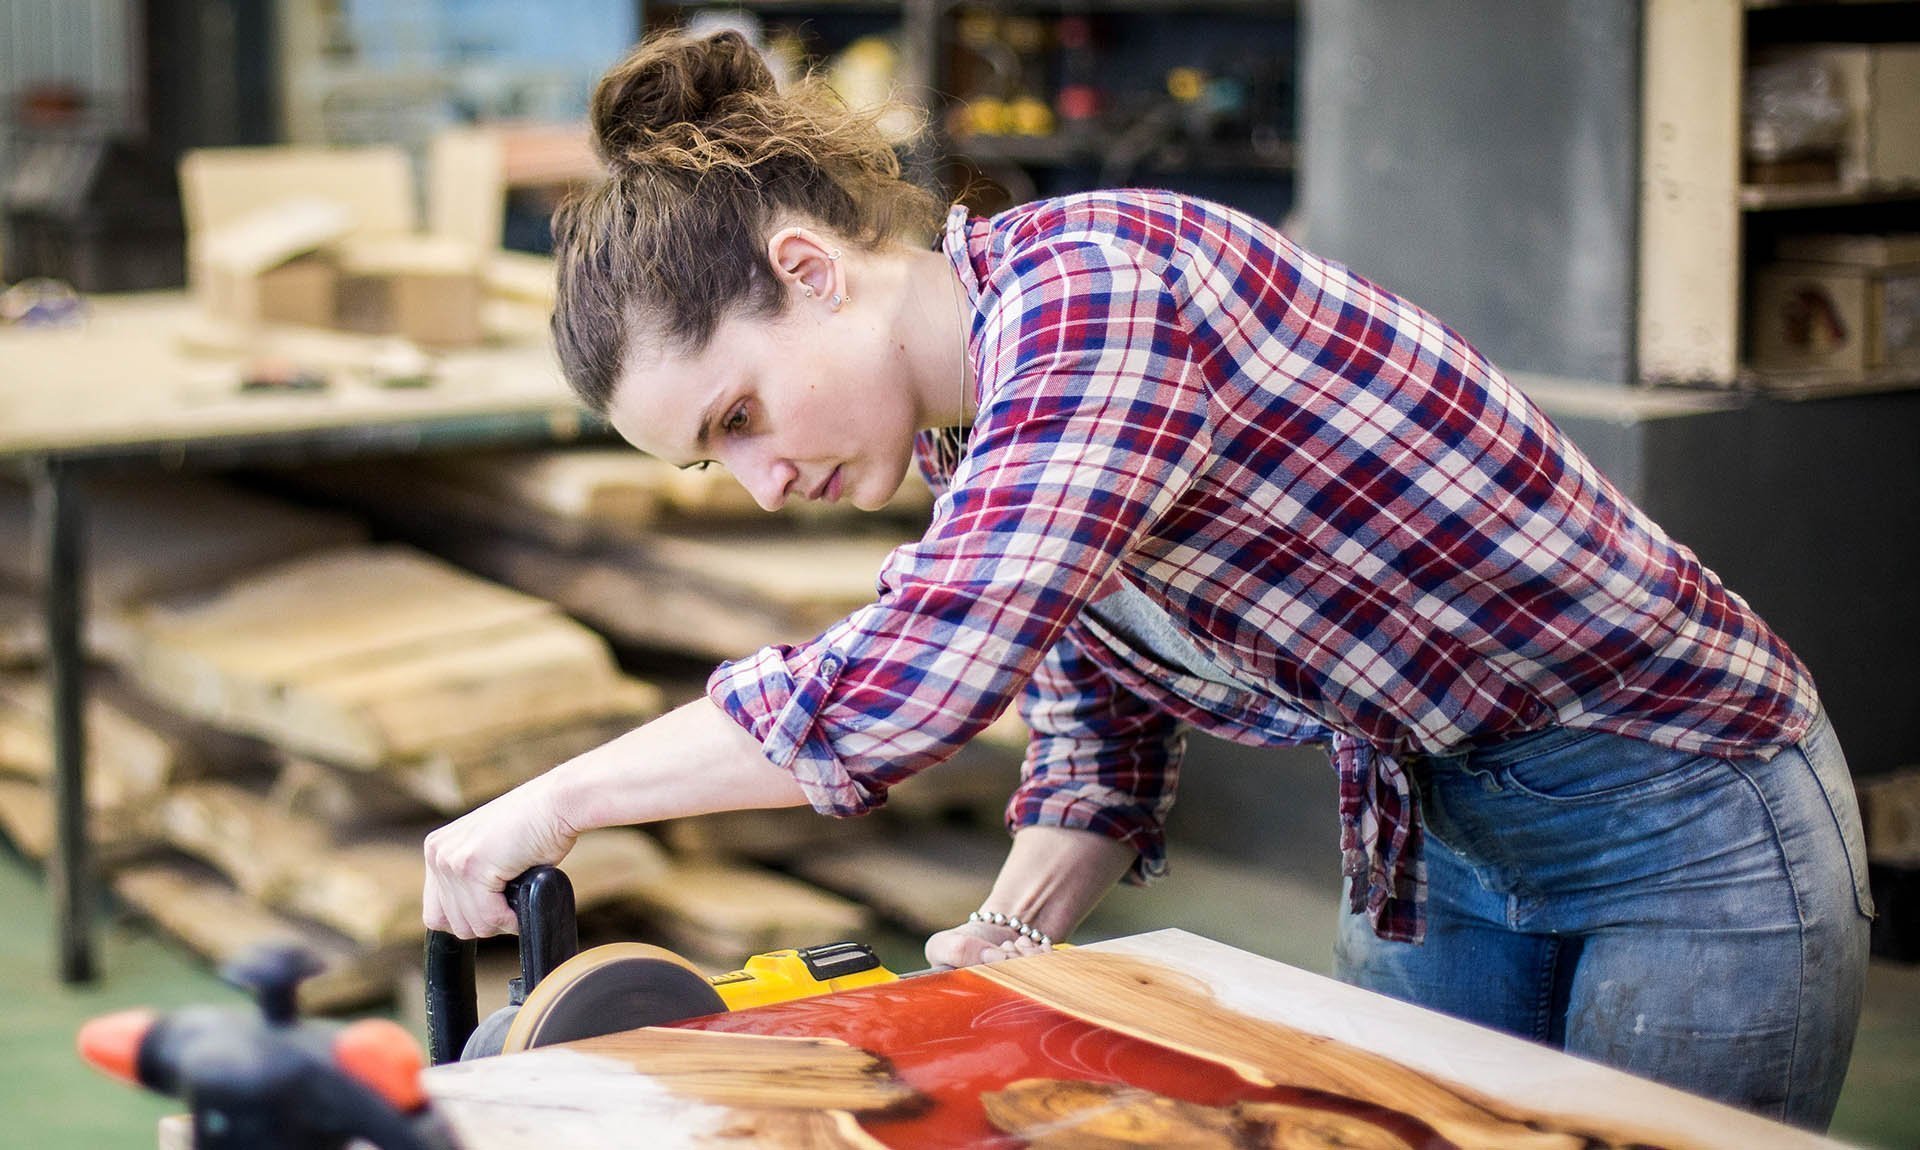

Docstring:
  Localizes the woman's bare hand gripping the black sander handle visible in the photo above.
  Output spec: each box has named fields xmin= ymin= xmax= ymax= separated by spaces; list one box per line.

xmin=432 ymin=774 xmax=578 ymax=939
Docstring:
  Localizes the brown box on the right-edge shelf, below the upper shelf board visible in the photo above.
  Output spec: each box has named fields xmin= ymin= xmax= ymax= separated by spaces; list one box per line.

xmin=1747 ymin=263 xmax=1920 ymax=374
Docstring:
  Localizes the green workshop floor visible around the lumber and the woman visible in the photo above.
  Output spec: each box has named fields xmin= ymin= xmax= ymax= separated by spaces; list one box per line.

xmin=0 ymin=847 xmax=1920 ymax=1150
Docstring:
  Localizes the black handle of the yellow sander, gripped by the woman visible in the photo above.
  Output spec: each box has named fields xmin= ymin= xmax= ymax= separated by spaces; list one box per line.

xmin=426 ymin=866 xmax=580 ymax=1066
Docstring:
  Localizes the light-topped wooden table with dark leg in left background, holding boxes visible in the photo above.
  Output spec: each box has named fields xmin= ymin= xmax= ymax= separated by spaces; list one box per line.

xmin=0 ymin=294 xmax=599 ymax=983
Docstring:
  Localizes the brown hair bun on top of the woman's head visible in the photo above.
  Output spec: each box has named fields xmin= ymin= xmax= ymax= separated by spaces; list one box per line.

xmin=591 ymin=31 xmax=776 ymax=165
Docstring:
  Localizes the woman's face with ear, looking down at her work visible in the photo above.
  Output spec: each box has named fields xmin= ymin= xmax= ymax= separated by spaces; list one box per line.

xmin=609 ymin=296 xmax=922 ymax=511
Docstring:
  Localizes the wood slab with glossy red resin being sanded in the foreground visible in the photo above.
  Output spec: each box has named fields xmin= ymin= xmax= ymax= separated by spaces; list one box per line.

xmin=424 ymin=931 xmax=1836 ymax=1150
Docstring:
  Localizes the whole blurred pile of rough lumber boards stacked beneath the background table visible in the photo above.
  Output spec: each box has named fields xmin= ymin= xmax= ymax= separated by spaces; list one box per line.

xmin=0 ymin=449 xmax=1052 ymax=1010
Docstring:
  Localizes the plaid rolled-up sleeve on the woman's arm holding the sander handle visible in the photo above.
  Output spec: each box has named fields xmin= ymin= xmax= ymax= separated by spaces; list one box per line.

xmin=707 ymin=240 xmax=1210 ymax=818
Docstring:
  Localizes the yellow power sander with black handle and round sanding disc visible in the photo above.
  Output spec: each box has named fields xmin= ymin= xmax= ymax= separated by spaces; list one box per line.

xmin=426 ymin=866 xmax=900 ymax=1066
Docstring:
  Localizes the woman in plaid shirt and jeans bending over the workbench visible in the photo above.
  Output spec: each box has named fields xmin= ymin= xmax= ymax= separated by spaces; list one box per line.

xmin=424 ymin=26 xmax=1870 ymax=1127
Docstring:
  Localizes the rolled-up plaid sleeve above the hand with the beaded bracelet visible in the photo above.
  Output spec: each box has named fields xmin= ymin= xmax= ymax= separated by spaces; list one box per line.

xmin=1006 ymin=626 xmax=1187 ymax=883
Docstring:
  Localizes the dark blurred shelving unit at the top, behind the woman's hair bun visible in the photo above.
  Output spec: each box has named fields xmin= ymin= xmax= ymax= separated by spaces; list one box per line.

xmin=645 ymin=0 xmax=1298 ymax=215
